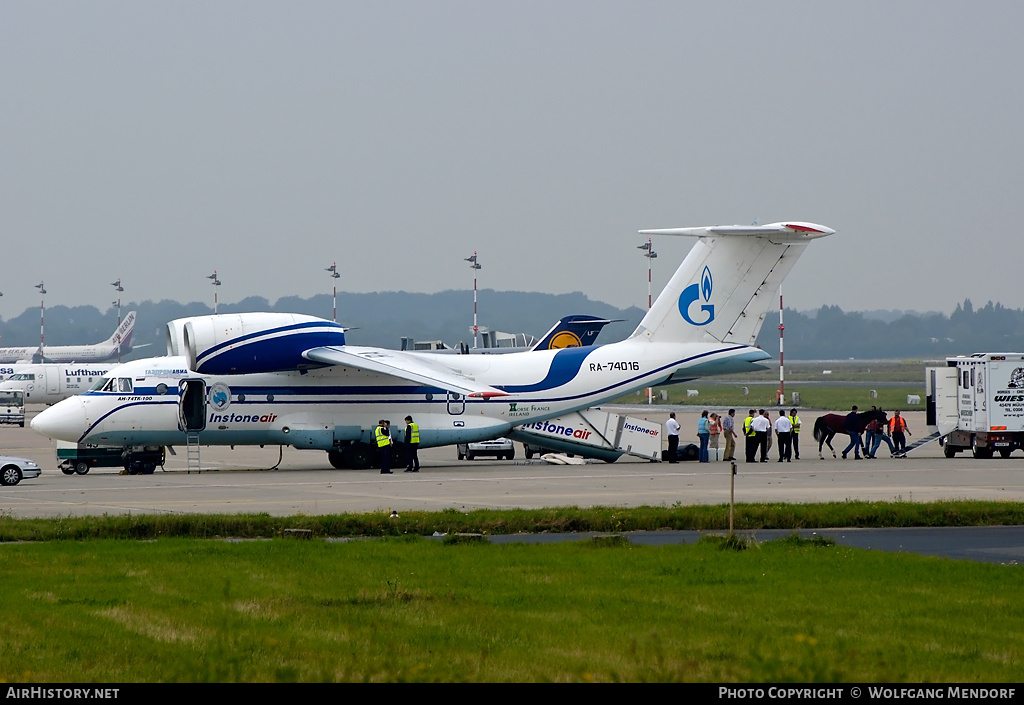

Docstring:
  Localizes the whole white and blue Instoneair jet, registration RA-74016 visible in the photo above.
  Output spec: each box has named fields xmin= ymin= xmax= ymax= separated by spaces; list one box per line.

xmin=32 ymin=221 xmax=835 ymax=471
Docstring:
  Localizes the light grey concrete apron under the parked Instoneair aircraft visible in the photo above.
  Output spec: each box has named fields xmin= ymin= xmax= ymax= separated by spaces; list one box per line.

xmin=0 ymin=407 xmax=1024 ymax=562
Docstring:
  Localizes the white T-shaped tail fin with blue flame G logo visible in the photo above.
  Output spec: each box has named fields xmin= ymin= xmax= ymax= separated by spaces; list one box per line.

xmin=631 ymin=221 xmax=836 ymax=345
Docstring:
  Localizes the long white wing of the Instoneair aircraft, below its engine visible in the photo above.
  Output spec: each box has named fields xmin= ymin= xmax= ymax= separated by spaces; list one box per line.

xmin=302 ymin=345 xmax=508 ymax=399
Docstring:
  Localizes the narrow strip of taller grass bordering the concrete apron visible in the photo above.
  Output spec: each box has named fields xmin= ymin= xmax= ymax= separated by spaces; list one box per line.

xmin=0 ymin=501 xmax=1024 ymax=542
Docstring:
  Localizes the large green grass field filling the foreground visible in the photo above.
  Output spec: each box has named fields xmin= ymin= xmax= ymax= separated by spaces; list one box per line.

xmin=0 ymin=538 xmax=1024 ymax=682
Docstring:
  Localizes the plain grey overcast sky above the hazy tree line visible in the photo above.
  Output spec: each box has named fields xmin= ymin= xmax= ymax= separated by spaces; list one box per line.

xmin=0 ymin=0 xmax=1024 ymax=321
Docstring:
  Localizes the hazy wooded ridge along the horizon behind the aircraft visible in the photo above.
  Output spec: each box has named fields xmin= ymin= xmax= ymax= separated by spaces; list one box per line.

xmin=0 ymin=289 xmax=1024 ymax=360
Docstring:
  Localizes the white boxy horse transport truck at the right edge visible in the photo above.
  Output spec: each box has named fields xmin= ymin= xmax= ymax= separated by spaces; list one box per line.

xmin=925 ymin=353 xmax=1024 ymax=458
